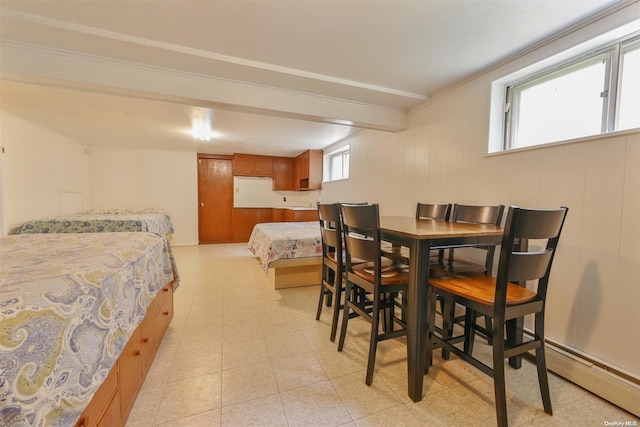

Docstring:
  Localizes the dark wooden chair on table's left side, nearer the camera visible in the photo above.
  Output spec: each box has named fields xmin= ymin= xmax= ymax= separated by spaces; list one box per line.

xmin=338 ymin=204 xmax=409 ymax=385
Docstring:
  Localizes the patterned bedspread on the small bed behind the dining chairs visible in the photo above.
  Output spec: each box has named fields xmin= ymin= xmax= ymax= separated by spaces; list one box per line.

xmin=247 ymin=221 xmax=322 ymax=271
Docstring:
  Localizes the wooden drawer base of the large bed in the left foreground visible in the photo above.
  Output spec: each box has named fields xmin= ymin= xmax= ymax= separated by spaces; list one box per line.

xmin=75 ymin=282 xmax=173 ymax=427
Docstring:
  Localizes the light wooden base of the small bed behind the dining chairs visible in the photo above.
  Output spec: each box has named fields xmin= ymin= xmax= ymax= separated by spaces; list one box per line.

xmin=268 ymin=257 xmax=322 ymax=289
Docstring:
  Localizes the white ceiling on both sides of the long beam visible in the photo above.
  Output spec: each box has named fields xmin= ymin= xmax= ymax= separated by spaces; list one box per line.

xmin=0 ymin=0 xmax=626 ymax=155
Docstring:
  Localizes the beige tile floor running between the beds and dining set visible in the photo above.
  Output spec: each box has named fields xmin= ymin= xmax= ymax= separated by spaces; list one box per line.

xmin=127 ymin=244 xmax=640 ymax=427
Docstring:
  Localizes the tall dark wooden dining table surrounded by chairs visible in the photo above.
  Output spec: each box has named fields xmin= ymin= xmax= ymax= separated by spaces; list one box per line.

xmin=380 ymin=216 xmax=503 ymax=402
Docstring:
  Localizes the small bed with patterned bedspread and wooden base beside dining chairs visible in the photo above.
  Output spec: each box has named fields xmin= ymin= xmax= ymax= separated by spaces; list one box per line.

xmin=247 ymin=221 xmax=322 ymax=289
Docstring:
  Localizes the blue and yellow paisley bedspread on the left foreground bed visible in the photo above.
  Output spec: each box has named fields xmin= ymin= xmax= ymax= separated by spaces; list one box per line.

xmin=0 ymin=232 xmax=173 ymax=426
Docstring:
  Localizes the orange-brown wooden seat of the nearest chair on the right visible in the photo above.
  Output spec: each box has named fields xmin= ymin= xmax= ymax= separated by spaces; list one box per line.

xmin=429 ymin=275 xmax=536 ymax=306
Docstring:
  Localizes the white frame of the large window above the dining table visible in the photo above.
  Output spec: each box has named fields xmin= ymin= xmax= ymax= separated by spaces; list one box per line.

xmin=502 ymin=32 xmax=640 ymax=152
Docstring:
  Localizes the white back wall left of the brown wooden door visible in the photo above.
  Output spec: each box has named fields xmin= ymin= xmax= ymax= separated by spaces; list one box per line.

xmin=89 ymin=147 xmax=198 ymax=246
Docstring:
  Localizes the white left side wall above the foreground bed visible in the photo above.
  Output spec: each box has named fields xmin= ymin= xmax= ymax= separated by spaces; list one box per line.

xmin=0 ymin=111 xmax=89 ymax=234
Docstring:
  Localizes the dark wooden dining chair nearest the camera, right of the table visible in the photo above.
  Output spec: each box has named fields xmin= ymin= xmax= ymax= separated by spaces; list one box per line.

xmin=427 ymin=206 xmax=568 ymax=426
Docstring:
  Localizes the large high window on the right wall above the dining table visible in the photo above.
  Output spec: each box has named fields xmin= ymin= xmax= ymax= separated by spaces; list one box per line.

xmin=503 ymin=37 xmax=640 ymax=150
